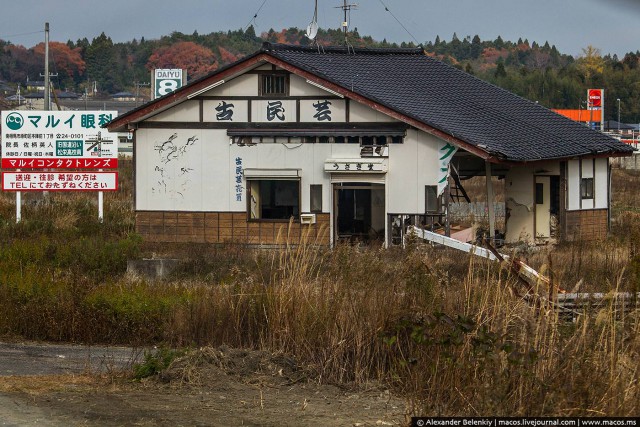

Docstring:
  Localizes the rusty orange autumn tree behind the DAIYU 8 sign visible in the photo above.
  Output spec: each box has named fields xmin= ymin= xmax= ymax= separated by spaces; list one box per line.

xmin=147 ymin=42 xmax=218 ymax=79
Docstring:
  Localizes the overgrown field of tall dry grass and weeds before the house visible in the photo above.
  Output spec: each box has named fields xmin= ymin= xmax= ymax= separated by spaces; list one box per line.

xmin=0 ymin=162 xmax=640 ymax=416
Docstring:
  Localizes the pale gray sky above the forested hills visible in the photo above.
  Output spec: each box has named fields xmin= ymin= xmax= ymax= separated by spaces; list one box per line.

xmin=0 ymin=0 xmax=640 ymax=57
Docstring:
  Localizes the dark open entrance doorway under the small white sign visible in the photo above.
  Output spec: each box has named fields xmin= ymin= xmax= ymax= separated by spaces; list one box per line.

xmin=333 ymin=183 xmax=385 ymax=243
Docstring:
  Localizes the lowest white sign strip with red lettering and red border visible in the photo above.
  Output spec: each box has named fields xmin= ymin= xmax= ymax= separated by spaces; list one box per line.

xmin=2 ymin=172 xmax=118 ymax=191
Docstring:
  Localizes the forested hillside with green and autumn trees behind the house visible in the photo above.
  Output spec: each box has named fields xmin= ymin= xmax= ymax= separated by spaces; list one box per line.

xmin=0 ymin=27 xmax=640 ymax=123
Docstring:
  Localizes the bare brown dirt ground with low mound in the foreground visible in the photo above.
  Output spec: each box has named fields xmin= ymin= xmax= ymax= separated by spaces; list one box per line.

xmin=0 ymin=347 xmax=406 ymax=426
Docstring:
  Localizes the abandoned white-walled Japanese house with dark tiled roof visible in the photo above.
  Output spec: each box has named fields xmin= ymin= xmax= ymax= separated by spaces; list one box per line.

xmin=108 ymin=43 xmax=633 ymax=245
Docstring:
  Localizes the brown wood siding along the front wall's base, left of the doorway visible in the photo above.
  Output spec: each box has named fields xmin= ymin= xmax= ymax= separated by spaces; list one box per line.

xmin=136 ymin=211 xmax=330 ymax=246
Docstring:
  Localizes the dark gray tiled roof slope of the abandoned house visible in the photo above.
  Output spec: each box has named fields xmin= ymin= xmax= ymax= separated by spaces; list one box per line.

xmin=262 ymin=43 xmax=633 ymax=161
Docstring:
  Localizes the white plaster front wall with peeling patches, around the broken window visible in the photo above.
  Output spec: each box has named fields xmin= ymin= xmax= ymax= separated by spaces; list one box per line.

xmin=136 ymin=129 xmax=344 ymax=212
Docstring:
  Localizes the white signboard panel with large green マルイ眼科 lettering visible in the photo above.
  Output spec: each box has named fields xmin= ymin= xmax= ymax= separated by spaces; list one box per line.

xmin=0 ymin=110 xmax=118 ymax=159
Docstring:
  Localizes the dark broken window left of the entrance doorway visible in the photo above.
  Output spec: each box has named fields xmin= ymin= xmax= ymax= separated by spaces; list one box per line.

xmin=247 ymin=179 xmax=300 ymax=221
